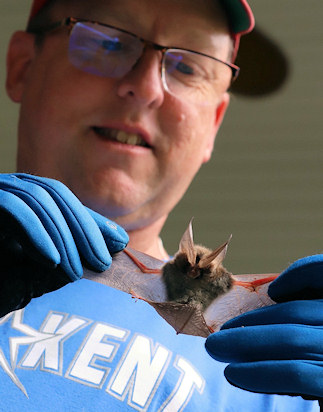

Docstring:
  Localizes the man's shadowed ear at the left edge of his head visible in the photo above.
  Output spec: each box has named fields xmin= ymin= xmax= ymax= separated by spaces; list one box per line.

xmin=6 ymin=31 xmax=35 ymax=103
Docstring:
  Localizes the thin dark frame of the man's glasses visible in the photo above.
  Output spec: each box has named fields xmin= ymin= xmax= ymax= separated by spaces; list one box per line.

xmin=28 ymin=17 xmax=240 ymax=91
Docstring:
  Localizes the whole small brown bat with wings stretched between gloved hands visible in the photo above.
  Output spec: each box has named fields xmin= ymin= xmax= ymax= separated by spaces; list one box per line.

xmin=84 ymin=220 xmax=278 ymax=337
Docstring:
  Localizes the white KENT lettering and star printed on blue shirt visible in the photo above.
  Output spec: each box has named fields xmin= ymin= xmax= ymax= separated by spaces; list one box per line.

xmin=0 ymin=310 xmax=205 ymax=412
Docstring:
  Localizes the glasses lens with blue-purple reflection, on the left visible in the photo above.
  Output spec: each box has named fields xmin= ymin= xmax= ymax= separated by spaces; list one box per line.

xmin=69 ymin=22 xmax=143 ymax=78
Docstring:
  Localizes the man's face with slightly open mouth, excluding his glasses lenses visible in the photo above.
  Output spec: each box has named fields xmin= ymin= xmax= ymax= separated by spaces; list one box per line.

xmin=7 ymin=0 xmax=230 ymax=230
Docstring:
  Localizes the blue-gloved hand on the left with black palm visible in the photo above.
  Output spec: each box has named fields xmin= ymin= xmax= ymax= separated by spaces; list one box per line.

xmin=0 ymin=173 xmax=128 ymax=317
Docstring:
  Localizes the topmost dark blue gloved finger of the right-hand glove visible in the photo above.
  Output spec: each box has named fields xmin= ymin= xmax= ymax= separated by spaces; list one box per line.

xmin=268 ymin=254 xmax=323 ymax=302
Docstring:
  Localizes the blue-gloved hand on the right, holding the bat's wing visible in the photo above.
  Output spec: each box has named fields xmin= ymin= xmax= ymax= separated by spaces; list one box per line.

xmin=206 ymin=255 xmax=323 ymax=401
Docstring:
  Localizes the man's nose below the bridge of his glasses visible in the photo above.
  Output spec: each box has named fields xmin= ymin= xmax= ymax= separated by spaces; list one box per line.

xmin=118 ymin=48 xmax=164 ymax=108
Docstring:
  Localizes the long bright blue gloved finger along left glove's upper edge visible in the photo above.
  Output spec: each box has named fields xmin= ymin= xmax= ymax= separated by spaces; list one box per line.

xmin=17 ymin=174 xmax=116 ymax=272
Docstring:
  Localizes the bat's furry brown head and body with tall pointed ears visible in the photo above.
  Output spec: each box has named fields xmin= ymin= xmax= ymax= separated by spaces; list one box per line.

xmin=162 ymin=221 xmax=233 ymax=310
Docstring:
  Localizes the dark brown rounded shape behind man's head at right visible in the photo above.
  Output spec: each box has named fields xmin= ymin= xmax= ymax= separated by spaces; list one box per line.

xmin=231 ymin=28 xmax=290 ymax=97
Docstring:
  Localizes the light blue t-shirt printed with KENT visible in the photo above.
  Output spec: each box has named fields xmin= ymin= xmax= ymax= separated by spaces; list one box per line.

xmin=0 ymin=279 xmax=319 ymax=412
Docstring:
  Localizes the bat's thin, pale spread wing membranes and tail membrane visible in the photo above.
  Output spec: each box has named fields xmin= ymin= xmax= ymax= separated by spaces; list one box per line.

xmin=83 ymin=248 xmax=274 ymax=337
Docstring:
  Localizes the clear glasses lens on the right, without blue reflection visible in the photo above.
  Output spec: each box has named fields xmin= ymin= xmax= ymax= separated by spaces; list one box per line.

xmin=163 ymin=49 xmax=232 ymax=104
